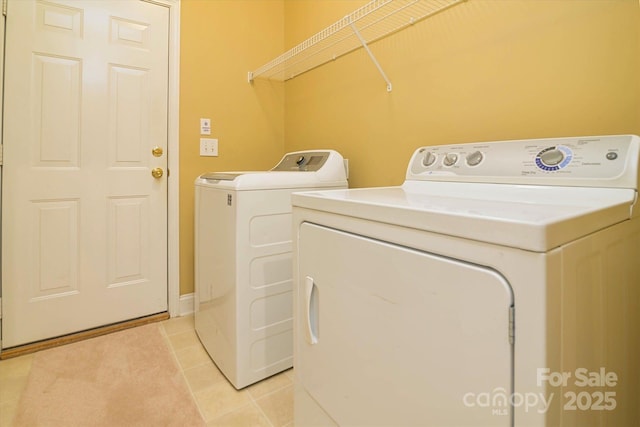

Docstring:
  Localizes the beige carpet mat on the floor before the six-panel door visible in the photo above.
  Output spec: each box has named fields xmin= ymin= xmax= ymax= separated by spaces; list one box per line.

xmin=14 ymin=324 xmax=204 ymax=427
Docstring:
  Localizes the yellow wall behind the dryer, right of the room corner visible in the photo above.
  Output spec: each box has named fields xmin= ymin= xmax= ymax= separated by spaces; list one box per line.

xmin=285 ymin=0 xmax=640 ymax=187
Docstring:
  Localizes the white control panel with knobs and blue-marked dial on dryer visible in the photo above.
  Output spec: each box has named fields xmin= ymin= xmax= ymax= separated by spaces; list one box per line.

xmin=407 ymin=135 xmax=640 ymax=188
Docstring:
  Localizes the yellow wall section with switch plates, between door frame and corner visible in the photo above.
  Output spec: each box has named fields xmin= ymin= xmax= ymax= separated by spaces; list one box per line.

xmin=179 ymin=0 xmax=284 ymax=295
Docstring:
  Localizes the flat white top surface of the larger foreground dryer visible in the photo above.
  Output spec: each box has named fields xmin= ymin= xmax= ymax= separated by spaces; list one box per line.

xmin=292 ymin=181 xmax=636 ymax=252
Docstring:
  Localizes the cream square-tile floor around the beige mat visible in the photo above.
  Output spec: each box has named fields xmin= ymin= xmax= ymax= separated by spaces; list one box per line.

xmin=0 ymin=316 xmax=293 ymax=427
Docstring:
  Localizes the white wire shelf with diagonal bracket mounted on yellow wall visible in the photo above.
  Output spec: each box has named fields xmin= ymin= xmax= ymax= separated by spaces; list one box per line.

xmin=248 ymin=0 xmax=466 ymax=90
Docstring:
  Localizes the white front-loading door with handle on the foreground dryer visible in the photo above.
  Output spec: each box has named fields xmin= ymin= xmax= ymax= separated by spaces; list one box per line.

xmin=294 ymin=223 xmax=513 ymax=427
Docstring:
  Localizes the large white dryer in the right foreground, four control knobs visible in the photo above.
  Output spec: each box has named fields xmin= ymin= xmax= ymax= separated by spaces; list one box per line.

xmin=293 ymin=135 xmax=640 ymax=427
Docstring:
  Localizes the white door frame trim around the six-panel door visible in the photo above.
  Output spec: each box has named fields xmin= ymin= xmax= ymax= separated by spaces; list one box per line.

xmin=0 ymin=0 xmax=181 ymax=319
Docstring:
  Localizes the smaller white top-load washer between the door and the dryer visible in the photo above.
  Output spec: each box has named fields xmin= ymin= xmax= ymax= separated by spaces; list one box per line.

xmin=195 ymin=150 xmax=347 ymax=389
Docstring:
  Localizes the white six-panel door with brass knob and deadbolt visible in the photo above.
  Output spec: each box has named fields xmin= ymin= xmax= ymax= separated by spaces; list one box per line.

xmin=2 ymin=0 xmax=169 ymax=348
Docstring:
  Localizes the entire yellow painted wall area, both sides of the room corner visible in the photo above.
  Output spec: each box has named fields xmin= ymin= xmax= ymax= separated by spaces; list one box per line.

xmin=180 ymin=0 xmax=640 ymax=294
